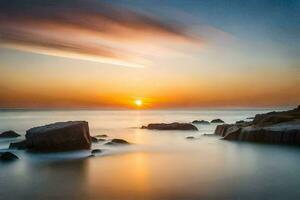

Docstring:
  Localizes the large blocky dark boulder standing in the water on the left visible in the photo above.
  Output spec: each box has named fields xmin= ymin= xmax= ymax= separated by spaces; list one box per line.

xmin=10 ymin=121 xmax=91 ymax=152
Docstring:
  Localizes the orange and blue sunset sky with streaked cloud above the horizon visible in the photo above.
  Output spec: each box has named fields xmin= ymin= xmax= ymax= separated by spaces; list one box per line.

xmin=0 ymin=0 xmax=300 ymax=109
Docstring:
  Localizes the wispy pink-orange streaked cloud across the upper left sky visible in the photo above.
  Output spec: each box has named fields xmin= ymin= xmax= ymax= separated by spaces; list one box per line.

xmin=0 ymin=0 xmax=199 ymax=67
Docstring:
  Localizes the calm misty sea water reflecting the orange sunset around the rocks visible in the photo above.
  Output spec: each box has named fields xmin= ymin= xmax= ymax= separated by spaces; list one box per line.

xmin=0 ymin=110 xmax=300 ymax=199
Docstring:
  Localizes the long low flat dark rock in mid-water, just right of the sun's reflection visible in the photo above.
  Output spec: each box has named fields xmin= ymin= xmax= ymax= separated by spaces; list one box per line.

xmin=142 ymin=122 xmax=198 ymax=131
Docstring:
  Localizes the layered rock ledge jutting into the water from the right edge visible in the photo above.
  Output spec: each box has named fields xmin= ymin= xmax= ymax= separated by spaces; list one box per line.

xmin=215 ymin=106 xmax=300 ymax=145
